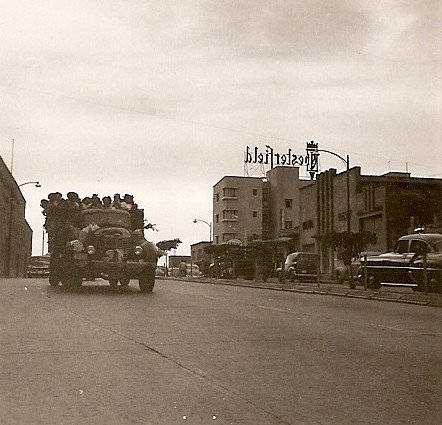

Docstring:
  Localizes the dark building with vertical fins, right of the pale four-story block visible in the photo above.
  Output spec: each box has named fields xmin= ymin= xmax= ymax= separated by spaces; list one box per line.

xmin=299 ymin=167 xmax=442 ymax=276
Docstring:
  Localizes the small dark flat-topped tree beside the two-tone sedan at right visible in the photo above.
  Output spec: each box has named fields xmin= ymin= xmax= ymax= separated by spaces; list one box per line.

xmin=321 ymin=232 xmax=377 ymax=288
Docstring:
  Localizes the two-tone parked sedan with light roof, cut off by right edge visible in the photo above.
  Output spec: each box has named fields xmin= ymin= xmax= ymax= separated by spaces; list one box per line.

xmin=359 ymin=233 xmax=442 ymax=292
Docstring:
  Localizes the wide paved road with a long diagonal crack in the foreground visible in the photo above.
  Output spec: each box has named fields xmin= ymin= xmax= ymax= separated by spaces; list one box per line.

xmin=0 ymin=279 xmax=442 ymax=425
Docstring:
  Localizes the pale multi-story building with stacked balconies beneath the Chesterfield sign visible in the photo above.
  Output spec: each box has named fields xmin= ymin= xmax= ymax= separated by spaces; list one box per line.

xmin=213 ymin=167 xmax=302 ymax=245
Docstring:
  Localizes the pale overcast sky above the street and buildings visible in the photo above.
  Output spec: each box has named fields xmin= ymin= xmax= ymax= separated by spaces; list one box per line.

xmin=0 ymin=0 xmax=442 ymax=254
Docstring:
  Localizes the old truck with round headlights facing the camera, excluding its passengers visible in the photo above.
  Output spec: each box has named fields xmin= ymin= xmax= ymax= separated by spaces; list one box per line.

xmin=49 ymin=208 xmax=159 ymax=292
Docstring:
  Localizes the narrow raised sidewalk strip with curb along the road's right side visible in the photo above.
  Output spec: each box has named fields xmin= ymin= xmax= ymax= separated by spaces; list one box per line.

xmin=157 ymin=276 xmax=442 ymax=307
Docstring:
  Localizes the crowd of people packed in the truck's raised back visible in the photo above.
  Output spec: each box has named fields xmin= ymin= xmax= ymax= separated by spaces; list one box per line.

xmin=40 ymin=192 xmax=144 ymax=252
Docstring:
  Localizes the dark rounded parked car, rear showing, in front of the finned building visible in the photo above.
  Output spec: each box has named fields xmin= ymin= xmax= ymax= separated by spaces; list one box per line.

xmin=279 ymin=252 xmax=319 ymax=281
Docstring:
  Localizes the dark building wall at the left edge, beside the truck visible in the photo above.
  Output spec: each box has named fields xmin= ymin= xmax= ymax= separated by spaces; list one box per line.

xmin=0 ymin=157 xmax=32 ymax=277
